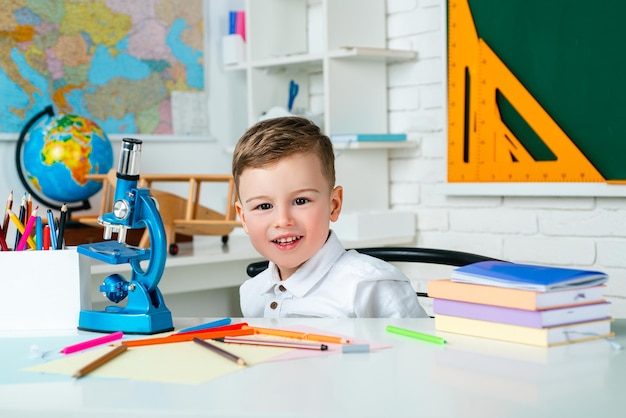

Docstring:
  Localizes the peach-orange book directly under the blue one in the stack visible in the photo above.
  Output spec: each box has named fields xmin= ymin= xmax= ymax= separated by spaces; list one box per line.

xmin=428 ymin=279 xmax=604 ymax=310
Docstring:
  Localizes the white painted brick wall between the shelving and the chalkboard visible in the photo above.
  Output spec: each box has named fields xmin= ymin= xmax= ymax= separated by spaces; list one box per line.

xmin=387 ymin=0 xmax=626 ymax=317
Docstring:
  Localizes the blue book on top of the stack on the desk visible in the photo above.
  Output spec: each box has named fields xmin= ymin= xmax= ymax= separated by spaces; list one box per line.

xmin=450 ymin=261 xmax=608 ymax=292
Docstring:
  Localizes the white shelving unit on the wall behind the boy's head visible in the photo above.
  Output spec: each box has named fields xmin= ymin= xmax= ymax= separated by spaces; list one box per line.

xmin=224 ymin=0 xmax=417 ymax=222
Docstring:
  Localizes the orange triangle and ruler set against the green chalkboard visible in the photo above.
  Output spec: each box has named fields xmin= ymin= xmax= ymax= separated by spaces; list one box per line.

xmin=448 ymin=0 xmax=605 ymax=182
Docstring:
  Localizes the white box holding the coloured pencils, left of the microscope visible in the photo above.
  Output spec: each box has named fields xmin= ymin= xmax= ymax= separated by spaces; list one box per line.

xmin=0 ymin=247 xmax=91 ymax=331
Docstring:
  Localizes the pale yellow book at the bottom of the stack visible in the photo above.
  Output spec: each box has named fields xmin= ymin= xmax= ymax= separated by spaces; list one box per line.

xmin=435 ymin=315 xmax=614 ymax=347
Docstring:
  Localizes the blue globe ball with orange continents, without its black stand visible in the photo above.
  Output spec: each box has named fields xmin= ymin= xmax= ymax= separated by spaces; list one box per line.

xmin=21 ymin=112 xmax=113 ymax=203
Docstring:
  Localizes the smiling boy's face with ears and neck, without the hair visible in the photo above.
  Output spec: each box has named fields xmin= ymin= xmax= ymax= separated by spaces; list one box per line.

xmin=235 ymin=154 xmax=343 ymax=280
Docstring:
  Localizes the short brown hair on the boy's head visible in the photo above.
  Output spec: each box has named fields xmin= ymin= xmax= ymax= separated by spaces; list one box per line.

xmin=233 ymin=116 xmax=335 ymax=194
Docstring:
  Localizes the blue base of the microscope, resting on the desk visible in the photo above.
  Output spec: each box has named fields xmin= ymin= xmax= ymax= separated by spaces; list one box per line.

xmin=78 ymin=306 xmax=174 ymax=334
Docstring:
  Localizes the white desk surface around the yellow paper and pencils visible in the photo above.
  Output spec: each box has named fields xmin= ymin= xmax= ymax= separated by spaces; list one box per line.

xmin=0 ymin=319 xmax=626 ymax=417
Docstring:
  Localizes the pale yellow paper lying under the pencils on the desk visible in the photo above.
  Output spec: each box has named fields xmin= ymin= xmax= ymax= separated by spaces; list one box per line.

xmin=24 ymin=342 xmax=293 ymax=384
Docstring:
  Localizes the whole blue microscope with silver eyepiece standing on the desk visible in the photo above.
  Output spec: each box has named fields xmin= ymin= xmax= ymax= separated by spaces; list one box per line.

xmin=77 ymin=138 xmax=174 ymax=334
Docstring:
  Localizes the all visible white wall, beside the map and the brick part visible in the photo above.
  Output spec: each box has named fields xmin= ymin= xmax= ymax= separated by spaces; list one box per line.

xmin=0 ymin=0 xmax=626 ymax=317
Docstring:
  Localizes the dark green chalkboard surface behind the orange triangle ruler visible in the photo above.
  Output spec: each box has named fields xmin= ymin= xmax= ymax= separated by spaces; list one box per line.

xmin=469 ymin=0 xmax=626 ymax=180
